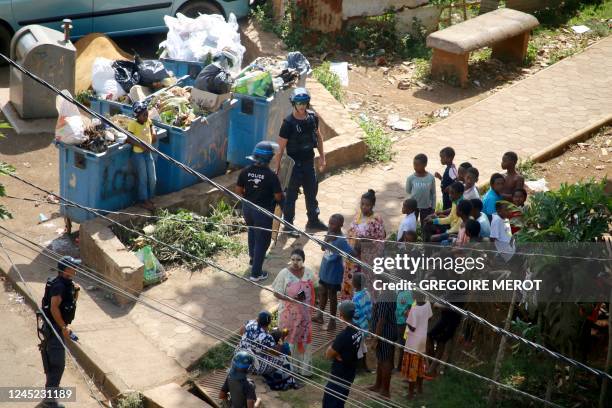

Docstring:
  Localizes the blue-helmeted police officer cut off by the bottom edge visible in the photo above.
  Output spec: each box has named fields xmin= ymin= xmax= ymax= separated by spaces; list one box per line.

xmin=219 ymin=351 xmax=257 ymax=408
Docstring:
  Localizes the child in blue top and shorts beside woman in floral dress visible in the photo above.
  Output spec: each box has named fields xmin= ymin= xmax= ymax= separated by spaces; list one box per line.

xmin=312 ymin=214 xmax=354 ymax=331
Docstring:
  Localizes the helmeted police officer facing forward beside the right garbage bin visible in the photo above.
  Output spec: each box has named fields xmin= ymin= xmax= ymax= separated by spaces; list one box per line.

xmin=276 ymin=88 xmax=327 ymax=236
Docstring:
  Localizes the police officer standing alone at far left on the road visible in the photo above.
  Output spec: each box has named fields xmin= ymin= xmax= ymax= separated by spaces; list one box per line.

xmin=41 ymin=256 xmax=81 ymax=408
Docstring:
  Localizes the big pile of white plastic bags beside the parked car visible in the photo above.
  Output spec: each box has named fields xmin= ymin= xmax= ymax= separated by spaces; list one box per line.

xmin=159 ymin=13 xmax=246 ymax=74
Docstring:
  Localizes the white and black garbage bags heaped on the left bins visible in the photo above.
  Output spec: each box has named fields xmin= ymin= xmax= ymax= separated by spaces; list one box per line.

xmin=91 ymin=55 xmax=176 ymax=103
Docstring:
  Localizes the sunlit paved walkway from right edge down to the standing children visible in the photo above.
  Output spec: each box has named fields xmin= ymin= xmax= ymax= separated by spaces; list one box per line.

xmin=288 ymin=37 xmax=612 ymax=241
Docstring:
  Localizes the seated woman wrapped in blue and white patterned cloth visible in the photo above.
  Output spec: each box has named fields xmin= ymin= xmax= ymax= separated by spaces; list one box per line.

xmin=236 ymin=311 xmax=299 ymax=391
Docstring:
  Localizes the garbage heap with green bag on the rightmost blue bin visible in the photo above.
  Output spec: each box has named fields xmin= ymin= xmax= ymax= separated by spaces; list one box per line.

xmin=233 ymin=51 xmax=311 ymax=98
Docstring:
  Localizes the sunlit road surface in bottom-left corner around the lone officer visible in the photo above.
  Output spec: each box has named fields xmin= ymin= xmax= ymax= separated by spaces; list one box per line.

xmin=0 ymin=280 xmax=104 ymax=408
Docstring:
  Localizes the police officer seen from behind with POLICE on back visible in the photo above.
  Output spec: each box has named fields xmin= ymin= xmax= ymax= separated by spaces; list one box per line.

xmin=236 ymin=141 xmax=283 ymax=282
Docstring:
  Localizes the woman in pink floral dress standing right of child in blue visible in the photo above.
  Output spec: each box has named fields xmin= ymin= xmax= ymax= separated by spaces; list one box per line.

xmin=340 ymin=189 xmax=387 ymax=300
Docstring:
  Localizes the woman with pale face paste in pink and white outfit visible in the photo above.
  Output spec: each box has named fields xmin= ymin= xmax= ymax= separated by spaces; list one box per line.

xmin=272 ymin=249 xmax=315 ymax=377
